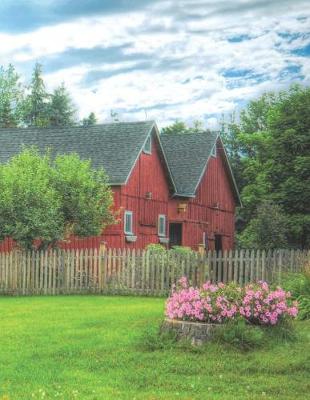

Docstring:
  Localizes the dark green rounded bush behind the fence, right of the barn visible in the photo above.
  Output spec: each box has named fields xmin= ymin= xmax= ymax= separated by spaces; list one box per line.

xmin=238 ymin=200 xmax=288 ymax=249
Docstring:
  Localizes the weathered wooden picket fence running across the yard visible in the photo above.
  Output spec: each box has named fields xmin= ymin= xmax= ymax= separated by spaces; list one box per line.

xmin=0 ymin=249 xmax=310 ymax=296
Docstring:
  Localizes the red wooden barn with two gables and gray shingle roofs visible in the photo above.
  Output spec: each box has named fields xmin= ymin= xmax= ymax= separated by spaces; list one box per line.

xmin=0 ymin=121 xmax=240 ymax=250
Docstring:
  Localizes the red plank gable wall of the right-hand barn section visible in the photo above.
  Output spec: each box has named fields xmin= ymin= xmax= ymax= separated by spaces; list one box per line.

xmin=169 ymin=144 xmax=236 ymax=249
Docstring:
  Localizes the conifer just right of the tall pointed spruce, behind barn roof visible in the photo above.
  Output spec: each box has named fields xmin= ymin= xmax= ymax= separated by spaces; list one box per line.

xmin=49 ymin=83 xmax=76 ymax=126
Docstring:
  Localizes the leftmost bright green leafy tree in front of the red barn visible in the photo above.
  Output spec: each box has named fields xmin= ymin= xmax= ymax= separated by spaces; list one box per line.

xmin=0 ymin=150 xmax=64 ymax=249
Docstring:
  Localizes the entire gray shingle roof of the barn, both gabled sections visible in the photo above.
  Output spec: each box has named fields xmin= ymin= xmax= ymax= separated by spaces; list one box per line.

xmin=0 ymin=121 xmax=240 ymax=203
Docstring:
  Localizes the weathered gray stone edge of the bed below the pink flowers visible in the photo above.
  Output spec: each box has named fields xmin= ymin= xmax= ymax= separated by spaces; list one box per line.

xmin=161 ymin=318 xmax=221 ymax=346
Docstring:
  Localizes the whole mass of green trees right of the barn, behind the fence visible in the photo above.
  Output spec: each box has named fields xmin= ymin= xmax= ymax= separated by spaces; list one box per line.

xmin=222 ymin=85 xmax=310 ymax=248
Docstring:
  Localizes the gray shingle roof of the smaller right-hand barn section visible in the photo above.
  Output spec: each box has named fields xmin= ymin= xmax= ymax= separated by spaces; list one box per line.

xmin=160 ymin=132 xmax=218 ymax=196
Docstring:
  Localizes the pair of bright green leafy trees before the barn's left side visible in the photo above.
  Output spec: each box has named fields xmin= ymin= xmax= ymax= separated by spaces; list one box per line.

xmin=0 ymin=148 xmax=113 ymax=249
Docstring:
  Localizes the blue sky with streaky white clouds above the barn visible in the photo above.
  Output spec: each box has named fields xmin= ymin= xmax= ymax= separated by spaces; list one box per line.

xmin=0 ymin=0 xmax=310 ymax=129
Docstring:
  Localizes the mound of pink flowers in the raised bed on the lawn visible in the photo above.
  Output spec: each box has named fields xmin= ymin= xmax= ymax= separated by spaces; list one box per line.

xmin=166 ymin=277 xmax=298 ymax=325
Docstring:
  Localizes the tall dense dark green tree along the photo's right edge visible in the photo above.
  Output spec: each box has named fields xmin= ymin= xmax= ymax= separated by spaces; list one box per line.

xmin=266 ymin=85 xmax=310 ymax=248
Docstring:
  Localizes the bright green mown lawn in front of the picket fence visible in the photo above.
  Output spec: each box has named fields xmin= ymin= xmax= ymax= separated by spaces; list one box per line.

xmin=0 ymin=296 xmax=310 ymax=400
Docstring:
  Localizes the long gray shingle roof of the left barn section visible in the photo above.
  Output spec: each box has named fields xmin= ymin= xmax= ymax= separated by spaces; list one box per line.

xmin=0 ymin=121 xmax=155 ymax=185
